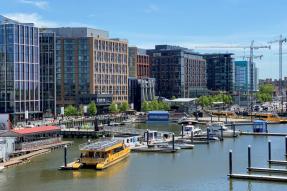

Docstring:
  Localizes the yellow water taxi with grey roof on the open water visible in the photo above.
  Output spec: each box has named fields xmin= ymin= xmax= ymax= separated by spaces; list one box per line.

xmin=61 ymin=139 xmax=130 ymax=170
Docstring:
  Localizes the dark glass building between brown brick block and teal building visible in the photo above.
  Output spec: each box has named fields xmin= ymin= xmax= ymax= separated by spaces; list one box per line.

xmin=203 ymin=53 xmax=235 ymax=93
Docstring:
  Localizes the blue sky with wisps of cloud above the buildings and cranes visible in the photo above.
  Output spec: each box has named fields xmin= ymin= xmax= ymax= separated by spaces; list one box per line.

xmin=0 ymin=0 xmax=287 ymax=79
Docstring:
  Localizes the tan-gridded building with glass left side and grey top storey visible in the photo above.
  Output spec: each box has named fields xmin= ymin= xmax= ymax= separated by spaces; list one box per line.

xmin=46 ymin=27 xmax=128 ymax=112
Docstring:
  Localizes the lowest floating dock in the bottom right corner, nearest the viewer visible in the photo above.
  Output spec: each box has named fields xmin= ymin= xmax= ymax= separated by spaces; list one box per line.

xmin=228 ymin=174 xmax=287 ymax=182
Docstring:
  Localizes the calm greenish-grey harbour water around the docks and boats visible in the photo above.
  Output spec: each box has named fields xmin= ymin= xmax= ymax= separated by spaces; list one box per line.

xmin=0 ymin=123 xmax=287 ymax=191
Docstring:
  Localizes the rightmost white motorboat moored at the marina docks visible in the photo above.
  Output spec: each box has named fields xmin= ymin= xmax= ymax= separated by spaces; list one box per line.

xmin=208 ymin=122 xmax=240 ymax=138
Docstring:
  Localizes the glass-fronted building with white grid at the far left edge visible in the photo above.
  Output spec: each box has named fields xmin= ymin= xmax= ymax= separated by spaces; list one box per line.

xmin=0 ymin=16 xmax=41 ymax=121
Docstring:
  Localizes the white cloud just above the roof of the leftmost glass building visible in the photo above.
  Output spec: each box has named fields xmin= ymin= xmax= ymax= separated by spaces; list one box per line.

xmin=3 ymin=13 xmax=59 ymax=27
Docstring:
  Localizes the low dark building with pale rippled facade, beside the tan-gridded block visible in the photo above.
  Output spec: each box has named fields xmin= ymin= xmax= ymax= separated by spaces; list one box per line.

xmin=129 ymin=77 xmax=155 ymax=111
